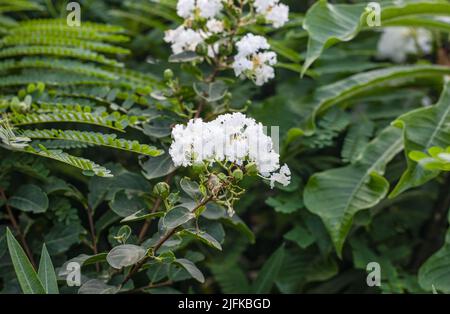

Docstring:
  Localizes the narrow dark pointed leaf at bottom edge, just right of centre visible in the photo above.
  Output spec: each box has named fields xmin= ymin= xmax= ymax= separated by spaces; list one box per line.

xmin=252 ymin=245 xmax=285 ymax=293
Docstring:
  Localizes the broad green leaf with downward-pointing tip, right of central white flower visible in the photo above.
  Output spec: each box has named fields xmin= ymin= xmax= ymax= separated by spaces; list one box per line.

xmin=303 ymin=127 xmax=403 ymax=255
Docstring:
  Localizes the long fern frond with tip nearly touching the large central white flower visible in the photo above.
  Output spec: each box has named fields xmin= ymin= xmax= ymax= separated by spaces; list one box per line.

xmin=19 ymin=129 xmax=163 ymax=157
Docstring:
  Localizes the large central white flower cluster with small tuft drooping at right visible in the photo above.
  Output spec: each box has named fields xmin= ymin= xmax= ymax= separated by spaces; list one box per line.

xmin=169 ymin=113 xmax=291 ymax=188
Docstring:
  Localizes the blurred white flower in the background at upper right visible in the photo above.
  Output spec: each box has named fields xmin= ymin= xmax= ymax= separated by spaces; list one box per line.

xmin=378 ymin=27 xmax=433 ymax=63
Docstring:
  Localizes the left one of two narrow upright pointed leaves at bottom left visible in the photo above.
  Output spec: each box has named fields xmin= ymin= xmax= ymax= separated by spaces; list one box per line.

xmin=6 ymin=228 xmax=45 ymax=294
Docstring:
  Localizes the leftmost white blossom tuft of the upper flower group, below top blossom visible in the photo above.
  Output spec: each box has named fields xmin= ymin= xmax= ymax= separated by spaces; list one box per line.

xmin=164 ymin=26 xmax=204 ymax=54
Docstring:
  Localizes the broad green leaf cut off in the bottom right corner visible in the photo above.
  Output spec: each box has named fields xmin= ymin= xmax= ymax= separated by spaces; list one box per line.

xmin=419 ymin=243 xmax=450 ymax=293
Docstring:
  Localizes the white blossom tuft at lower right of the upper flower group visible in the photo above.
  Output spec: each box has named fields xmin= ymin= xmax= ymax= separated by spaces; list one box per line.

xmin=233 ymin=33 xmax=277 ymax=86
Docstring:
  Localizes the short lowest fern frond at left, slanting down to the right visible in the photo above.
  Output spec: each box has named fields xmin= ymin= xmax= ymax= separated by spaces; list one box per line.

xmin=21 ymin=145 xmax=113 ymax=177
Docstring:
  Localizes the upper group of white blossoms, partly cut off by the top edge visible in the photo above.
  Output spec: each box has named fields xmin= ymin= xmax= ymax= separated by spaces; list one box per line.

xmin=164 ymin=0 xmax=289 ymax=86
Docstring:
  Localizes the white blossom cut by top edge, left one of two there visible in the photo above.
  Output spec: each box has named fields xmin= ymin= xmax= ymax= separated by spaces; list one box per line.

xmin=177 ymin=0 xmax=223 ymax=19
